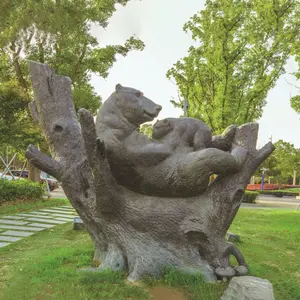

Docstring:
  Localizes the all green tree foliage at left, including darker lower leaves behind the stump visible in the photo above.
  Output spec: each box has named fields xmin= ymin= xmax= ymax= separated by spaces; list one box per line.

xmin=0 ymin=0 xmax=144 ymax=169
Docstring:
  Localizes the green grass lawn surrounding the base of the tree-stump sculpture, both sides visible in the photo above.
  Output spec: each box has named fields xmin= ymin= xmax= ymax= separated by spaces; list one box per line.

xmin=0 ymin=209 xmax=300 ymax=300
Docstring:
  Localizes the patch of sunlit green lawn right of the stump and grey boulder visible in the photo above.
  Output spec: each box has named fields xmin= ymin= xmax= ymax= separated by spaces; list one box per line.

xmin=230 ymin=209 xmax=300 ymax=300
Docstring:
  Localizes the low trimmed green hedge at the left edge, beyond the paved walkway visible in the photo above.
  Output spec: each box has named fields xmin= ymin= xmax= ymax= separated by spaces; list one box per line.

xmin=0 ymin=179 xmax=45 ymax=203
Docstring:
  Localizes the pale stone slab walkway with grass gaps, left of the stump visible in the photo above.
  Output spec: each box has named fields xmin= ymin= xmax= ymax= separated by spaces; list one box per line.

xmin=0 ymin=206 xmax=77 ymax=248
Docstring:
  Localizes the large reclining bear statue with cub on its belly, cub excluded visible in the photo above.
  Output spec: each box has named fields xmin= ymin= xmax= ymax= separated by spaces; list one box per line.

xmin=96 ymin=84 xmax=247 ymax=197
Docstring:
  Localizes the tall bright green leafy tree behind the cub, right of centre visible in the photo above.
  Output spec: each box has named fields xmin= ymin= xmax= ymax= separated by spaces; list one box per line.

xmin=167 ymin=0 xmax=300 ymax=133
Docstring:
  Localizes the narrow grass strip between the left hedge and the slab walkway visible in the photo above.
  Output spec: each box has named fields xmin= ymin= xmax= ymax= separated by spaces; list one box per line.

xmin=0 ymin=198 xmax=70 ymax=216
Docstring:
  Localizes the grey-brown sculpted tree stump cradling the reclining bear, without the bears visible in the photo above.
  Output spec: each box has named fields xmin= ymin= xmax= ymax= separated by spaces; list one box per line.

xmin=26 ymin=62 xmax=274 ymax=281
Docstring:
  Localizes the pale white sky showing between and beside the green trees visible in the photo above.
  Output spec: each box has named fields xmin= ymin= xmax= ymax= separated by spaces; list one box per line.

xmin=92 ymin=0 xmax=300 ymax=148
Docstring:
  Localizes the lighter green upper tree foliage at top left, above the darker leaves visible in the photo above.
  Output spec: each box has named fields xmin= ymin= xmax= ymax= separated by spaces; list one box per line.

xmin=0 ymin=0 xmax=144 ymax=112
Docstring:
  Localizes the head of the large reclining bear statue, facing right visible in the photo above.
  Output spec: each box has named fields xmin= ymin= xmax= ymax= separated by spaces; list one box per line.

xmin=114 ymin=84 xmax=162 ymax=126
